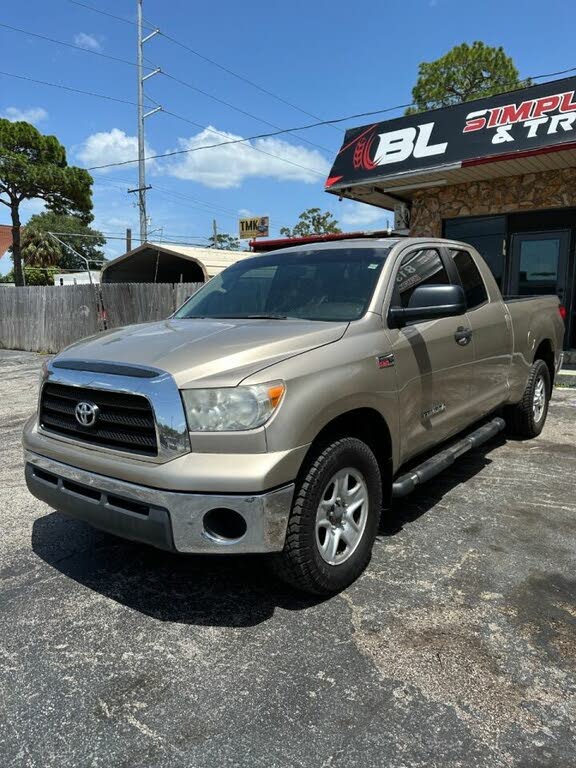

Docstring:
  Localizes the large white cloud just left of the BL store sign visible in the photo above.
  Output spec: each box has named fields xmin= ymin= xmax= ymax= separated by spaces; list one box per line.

xmin=163 ymin=126 xmax=330 ymax=189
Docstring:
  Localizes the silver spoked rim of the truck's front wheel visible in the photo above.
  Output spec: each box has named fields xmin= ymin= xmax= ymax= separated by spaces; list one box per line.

xmin=316 ymin=467 xmax=368 ymax=565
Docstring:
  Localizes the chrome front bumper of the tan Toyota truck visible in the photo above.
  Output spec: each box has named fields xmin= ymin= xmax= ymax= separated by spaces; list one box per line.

xmin=24 ymin=450 xmax=294 ymax=554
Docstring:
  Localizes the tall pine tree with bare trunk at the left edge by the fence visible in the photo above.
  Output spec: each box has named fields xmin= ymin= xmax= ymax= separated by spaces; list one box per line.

xmin=0 ymin=119 xmax=92 ymax=285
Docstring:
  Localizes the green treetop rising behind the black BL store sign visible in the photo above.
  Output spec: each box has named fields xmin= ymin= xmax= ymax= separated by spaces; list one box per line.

xmin=406 ymin=40 xmax=530 ymax=115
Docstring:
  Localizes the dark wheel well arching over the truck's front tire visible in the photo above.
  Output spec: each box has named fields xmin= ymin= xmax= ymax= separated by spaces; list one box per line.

xmin=303 ymin=408 xmax=392 ymax=506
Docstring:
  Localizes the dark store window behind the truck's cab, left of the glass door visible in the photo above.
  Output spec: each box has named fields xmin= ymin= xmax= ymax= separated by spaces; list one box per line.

xmin=443 ymin=216 xmax=506 ymax=289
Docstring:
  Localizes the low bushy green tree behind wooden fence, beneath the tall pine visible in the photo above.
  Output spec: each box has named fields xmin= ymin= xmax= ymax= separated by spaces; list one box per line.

xmin=21 ymin=211 xmax=106 ymax=270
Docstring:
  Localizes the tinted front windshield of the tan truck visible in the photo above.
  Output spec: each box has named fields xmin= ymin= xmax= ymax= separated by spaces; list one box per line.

xmin=174 ymin=247 xmax=390 ymax=321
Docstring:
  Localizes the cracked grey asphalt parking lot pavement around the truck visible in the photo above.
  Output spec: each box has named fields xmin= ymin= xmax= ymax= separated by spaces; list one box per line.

xmin=0 ymin=351 xmax=576 ymax=768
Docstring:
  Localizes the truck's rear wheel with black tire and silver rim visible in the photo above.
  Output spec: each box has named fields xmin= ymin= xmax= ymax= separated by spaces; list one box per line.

xmin=505 ymin=360 xmax=552 ymax=438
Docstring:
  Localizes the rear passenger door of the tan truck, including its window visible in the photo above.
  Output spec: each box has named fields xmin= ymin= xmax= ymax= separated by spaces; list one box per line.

xmin=448 ymin=248 xmax=514 ymax=420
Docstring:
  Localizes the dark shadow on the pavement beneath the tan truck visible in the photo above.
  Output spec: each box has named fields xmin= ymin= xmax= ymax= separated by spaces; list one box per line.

xmin=32 ymin=442 xmax=504 ymax=627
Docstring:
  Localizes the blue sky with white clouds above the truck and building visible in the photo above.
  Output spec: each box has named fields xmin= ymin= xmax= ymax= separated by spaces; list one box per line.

xmin=0 ymin=0 xmax=576 ymax=272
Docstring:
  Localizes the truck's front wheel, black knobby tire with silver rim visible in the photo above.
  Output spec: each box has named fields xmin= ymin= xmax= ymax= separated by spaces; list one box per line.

xmin=272 ymin=437 xmax=382 ymax=595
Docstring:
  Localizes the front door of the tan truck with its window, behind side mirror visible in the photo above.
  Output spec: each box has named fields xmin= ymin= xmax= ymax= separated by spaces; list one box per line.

xmin=388 ymin=247 xmax=474 ymax=461
